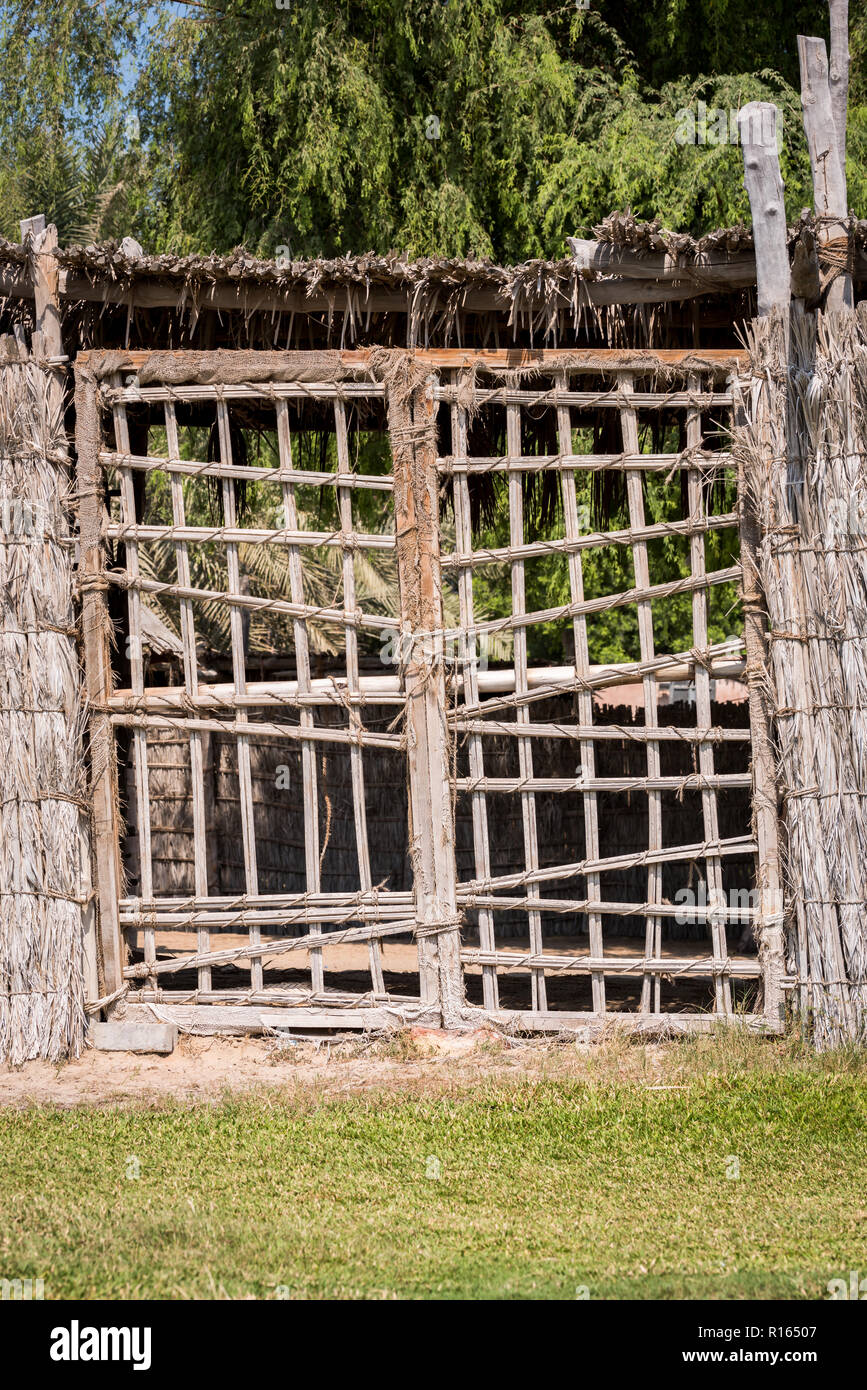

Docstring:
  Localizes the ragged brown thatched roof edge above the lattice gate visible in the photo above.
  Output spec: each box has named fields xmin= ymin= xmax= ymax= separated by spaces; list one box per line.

xmin=0 ymin=213 xmax=867 ymax=348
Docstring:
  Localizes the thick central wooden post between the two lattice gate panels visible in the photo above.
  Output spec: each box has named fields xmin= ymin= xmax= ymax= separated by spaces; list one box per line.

xmin=389 ymin=366 xmax=463 ymax=1027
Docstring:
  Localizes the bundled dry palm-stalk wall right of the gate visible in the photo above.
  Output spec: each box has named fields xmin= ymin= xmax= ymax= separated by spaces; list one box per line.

xmin=735 ymin=306 xmax=867 ymax=1048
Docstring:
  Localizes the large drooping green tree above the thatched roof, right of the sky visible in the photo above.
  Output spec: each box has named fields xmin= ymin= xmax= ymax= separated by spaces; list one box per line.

xmin=131 ymin=0 xmax=857 ymax=261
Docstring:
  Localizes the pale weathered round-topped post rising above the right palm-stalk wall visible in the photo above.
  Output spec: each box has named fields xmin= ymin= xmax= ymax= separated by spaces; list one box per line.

xmin=738 ymin=101 xmax=791 ymax=316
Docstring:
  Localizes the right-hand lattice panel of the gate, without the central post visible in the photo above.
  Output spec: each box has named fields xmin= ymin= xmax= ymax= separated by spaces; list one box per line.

xmin=439 ymin=354 xmax=782 ymax=1029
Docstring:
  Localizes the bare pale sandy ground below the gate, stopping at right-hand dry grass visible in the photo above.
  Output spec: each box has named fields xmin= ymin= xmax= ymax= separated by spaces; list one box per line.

xmin=0 ymin=1034 xmax=622 ymax=1109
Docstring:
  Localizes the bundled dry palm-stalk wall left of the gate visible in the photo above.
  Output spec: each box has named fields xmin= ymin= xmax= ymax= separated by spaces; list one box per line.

xmin=0 ymin=341 xmax=86 ymax=1065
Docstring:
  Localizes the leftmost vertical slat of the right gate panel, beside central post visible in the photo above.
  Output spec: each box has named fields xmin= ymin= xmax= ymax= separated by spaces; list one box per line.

xmin=452 ymin=374 xmax=499 ymax=1009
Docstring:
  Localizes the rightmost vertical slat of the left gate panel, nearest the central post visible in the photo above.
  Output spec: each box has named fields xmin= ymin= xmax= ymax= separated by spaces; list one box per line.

xmin=335 ymin=398 xmax=385 ymax=994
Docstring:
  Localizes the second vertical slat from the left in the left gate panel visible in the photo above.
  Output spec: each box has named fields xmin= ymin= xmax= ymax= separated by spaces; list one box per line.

xmin=165 ymin=400 xmax=212 ymax=991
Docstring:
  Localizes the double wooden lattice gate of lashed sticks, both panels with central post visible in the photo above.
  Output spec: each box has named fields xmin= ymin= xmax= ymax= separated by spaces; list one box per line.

xmin=76 ymin=352 xmax=781 ymax=1030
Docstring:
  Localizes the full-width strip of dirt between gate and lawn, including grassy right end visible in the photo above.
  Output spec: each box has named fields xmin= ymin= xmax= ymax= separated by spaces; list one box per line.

xmin=0 ymin=1030 xmax=839 ymax=1111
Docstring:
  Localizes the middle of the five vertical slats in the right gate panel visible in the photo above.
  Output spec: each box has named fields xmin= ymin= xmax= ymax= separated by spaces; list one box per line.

xmin=557 ymin=375 xmax=606 ymax=1013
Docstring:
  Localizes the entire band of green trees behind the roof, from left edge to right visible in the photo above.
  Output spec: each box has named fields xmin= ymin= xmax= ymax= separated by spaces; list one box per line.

xmin=0 ymin=0 xmax=867 ymax=261
